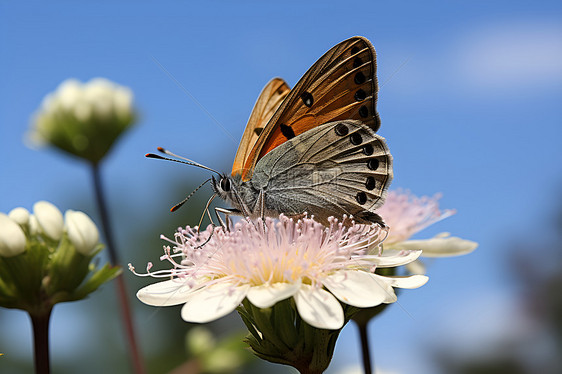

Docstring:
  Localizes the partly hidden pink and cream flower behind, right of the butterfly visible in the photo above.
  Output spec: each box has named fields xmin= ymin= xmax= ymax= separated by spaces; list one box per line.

xmin=378 ymin=190 xmax=478 ymax=274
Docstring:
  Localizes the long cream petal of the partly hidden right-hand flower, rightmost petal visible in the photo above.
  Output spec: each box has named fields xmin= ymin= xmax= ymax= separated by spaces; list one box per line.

xmin=399 ymin=236 xmax=478 ymax=257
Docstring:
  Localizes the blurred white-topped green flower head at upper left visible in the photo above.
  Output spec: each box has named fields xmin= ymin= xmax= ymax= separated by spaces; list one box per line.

xmin=28 ymin=78 xmax=135 ymax=164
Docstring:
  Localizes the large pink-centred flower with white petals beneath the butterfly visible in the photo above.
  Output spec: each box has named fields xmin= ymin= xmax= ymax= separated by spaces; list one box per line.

xmin=130 ymin=215 xmax=427 ymax=330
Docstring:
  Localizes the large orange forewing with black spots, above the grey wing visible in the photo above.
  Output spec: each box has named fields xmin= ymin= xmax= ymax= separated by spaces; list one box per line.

xmin=238 ymin=36 xmax=380 ymax=180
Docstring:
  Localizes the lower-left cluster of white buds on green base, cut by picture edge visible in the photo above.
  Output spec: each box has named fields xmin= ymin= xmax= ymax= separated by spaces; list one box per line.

xmin=0 ymin=201 xmax=121 ymax=315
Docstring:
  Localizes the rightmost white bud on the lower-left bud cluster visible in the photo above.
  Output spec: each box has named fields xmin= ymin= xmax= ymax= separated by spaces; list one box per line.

xmin=64 ymin=210 xmax=99 ymax=256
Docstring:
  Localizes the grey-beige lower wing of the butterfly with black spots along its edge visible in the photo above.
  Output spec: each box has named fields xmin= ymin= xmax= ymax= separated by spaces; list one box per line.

xmin=249 ymin=120 xmax=392 ymax=223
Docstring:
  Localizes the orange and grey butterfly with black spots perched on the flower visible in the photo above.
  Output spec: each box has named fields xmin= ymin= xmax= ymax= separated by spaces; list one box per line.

xmin=151 ymin=36 xmax=393 ymax=226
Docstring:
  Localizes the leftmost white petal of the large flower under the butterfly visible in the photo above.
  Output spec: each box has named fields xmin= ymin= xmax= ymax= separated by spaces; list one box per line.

xmin=137 ymin=279 xmax=197 ymax=306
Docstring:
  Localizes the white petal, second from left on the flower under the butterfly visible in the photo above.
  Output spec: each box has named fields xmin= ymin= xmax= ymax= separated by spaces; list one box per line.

xmin=181 ymin=283 xmax=250 ymax=323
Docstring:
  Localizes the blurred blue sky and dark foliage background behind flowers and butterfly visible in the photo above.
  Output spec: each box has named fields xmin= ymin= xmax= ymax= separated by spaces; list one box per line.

xmin=0 ymin=0 xmax=562 ymax=373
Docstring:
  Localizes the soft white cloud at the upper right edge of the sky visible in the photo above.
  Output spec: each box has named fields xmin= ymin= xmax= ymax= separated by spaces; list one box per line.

xmin=452 ymin=20 xmax=562 ymax=89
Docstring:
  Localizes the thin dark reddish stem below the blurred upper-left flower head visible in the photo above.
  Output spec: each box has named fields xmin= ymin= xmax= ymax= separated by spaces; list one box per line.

xmin=92 ymin=163 xmax=146 ymax=374
